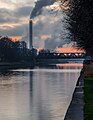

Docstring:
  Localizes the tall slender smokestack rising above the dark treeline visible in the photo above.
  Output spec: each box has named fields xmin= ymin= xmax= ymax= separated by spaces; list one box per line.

xmin=29 ymin=19 xmax=33 ymax=49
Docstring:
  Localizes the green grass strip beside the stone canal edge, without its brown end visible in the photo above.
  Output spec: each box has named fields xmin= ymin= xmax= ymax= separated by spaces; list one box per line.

xmin=84 ymin=75 xmax=93 ymax=120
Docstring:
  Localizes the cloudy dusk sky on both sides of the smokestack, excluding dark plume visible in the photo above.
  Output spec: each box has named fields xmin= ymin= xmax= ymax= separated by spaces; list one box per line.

xmin=0 ymin=0 xmax=72 ymax=49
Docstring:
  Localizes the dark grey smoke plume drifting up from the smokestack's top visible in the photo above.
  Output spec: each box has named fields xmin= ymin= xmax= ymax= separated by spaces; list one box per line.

xmin=30 ymin=0 xmax=55 ymax=18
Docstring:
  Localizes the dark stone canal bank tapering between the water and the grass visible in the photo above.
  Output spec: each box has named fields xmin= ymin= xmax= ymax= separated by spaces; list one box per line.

xmin=64 ymin=70 xmax=84 ymax=120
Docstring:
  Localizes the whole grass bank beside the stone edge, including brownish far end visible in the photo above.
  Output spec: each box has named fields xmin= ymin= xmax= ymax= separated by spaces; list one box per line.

xmin=84 ymin=64 xmax=93 ymax=120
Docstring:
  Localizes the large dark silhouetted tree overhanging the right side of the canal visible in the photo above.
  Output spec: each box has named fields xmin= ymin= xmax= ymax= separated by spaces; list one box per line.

xmin=58 ymin=0 xmax=93 ymax=55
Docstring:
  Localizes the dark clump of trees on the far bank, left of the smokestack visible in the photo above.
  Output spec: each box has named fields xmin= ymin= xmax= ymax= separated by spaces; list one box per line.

xmin=0 ymin=36 xmax=37 ymax=63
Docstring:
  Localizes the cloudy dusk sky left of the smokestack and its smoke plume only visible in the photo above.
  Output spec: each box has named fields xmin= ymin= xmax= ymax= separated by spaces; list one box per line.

xmin=0 ymin=0 xmax=34 ymax=36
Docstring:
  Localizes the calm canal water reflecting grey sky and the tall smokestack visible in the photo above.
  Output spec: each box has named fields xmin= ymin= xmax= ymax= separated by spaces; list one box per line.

xmin=0 ymin=64 xmax=82 ymax=120
